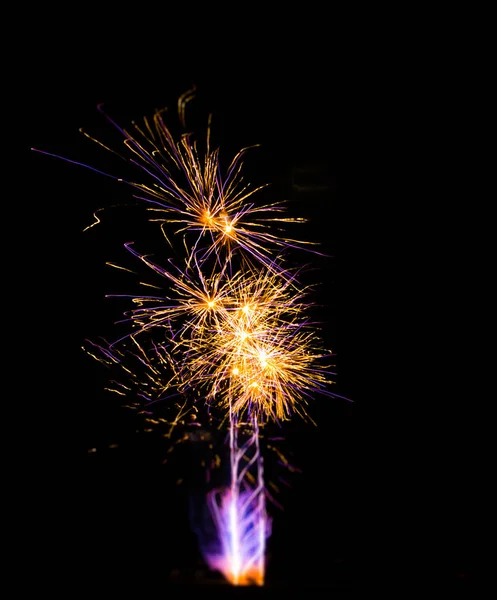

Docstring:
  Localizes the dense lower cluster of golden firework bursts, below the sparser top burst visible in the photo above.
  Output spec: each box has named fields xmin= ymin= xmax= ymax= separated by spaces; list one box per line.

xmin=91 ymin=241 xmax=331 ymax=422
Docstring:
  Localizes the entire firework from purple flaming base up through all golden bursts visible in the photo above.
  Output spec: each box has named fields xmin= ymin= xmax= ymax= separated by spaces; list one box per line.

xmin=34 ymin=91 xmax=335 ymax=585
